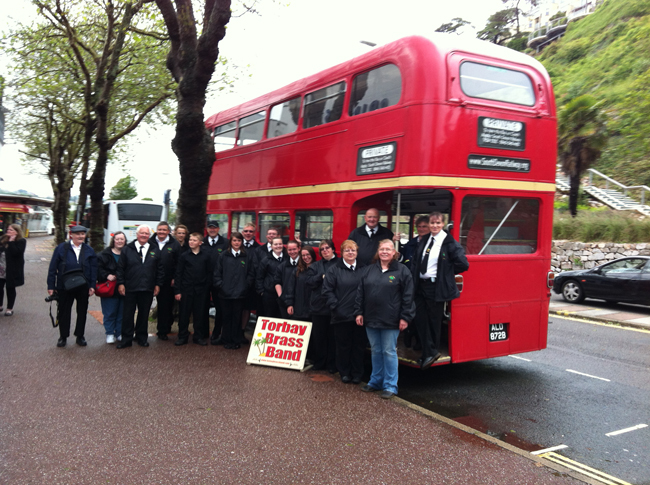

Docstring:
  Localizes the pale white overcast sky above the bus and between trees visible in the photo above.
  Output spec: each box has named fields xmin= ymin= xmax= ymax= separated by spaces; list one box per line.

xmin=0 ymin=0 xmax=503 ymax=201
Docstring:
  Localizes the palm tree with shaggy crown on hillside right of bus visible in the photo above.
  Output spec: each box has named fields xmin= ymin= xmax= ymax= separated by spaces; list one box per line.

xmin=557 ymin=94 xmax=608 ymax=217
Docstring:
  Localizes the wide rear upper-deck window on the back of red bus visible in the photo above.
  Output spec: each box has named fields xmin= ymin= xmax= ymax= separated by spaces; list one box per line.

xmin=460 ymin=61 xmax=535 ymax=106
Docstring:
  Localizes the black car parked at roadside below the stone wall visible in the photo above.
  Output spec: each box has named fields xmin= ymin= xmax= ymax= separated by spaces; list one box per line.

xmin=553 ymin=256 xmax=650 ymax=305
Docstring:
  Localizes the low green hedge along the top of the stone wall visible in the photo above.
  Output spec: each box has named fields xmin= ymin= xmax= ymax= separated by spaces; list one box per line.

xmin=553 ymin=211 xmax=650 ymax=243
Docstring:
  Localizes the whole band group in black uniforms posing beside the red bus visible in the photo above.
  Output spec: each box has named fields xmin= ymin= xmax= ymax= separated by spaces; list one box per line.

xmin=48 ymin=209 xmax=469 ymax=398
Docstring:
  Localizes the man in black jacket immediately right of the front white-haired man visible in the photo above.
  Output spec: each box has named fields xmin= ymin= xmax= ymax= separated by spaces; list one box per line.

xmin=149 ymin=221 xmax=181 ymax=340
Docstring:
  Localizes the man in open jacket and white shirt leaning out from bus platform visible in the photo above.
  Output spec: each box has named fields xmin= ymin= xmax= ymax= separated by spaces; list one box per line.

xmin=411 ymin=212 xmax=469 ymax=369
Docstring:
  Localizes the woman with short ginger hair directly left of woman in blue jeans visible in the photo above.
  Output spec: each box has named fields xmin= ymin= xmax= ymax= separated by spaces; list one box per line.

xmin=323 ymin=239 xmax=366 ymax=384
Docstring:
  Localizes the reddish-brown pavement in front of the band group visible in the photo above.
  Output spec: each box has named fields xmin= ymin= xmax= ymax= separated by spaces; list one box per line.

xmin=0 ymin=239 xmax=591 ymax=485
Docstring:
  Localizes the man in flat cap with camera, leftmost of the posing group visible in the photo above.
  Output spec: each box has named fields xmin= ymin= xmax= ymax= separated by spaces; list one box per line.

xmin=47 ymin=226 xmax=97 ymax=347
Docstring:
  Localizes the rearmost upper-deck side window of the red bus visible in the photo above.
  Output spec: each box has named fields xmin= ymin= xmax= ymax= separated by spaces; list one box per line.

xmin=350 ymin=64 xmax=402 ymax=116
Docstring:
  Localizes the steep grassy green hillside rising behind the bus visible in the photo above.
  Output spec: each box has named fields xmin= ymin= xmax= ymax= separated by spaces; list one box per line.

xmin=538 ymin=0 xmax=650 ymax=186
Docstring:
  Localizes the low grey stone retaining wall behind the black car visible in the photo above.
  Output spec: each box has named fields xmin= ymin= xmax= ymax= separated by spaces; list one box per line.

xmin=551 ymin=240 xmax=650 ymax=272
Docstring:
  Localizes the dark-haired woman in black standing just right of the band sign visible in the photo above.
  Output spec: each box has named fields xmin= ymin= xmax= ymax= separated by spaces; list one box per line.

xmin=306 ymin=239 xmax=338 ymax=374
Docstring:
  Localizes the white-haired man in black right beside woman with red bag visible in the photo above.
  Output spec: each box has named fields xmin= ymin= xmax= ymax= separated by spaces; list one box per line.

xmin=116 ymin=224 xmax=165 ymax=349
